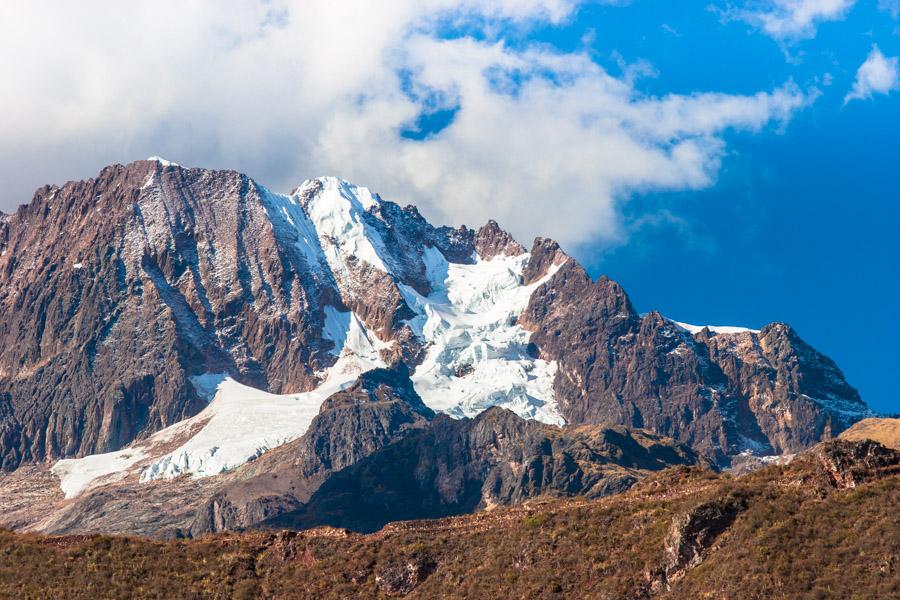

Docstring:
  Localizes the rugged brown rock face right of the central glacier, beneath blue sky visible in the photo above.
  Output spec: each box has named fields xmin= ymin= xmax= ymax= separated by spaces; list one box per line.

xmin=520 ymin=239 xmax=867 ymax=463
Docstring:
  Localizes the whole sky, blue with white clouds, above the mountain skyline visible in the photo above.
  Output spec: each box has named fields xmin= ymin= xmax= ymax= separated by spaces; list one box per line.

xmin=0 ymin=0 xmax=900 ymax=412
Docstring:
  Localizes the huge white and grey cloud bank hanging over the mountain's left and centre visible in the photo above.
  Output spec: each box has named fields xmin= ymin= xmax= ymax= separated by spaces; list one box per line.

xmin=0 ymin=0 xmax=815 ymax=244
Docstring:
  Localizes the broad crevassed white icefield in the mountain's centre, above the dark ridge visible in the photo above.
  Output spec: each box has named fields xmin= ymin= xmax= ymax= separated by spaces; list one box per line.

xmin=400 ymin=248 xmax=565 ymax=425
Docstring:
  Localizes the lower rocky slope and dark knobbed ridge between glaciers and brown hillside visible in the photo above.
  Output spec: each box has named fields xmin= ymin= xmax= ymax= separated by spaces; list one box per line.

xmin=0 ymin=363 xmax=705 ymax=538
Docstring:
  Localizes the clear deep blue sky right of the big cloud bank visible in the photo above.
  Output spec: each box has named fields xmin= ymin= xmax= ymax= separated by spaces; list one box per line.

xmin=538 ymin=1 xmax=900 ymax=412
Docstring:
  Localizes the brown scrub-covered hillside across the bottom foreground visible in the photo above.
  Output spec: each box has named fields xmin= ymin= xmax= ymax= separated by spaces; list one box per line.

xmin=0 ymin=440 xmax=900 ymax=599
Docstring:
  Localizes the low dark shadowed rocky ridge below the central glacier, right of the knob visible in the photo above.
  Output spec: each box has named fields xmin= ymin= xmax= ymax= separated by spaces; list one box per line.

xmin=256 ymin=407 xmax=701 ymax=531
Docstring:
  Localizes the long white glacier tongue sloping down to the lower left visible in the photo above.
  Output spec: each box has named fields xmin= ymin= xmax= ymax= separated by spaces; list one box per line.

xmin=52 ymin=307 xmax=393 ymax=498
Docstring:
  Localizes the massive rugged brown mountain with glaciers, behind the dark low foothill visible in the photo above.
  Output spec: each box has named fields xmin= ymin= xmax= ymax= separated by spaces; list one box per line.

xmin=0 ymin=159 xmax=869 ymax=508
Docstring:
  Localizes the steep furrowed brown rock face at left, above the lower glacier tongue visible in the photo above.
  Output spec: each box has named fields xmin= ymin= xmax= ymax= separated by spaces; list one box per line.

xmin=0 ymin=161 xmax=322 ymax=468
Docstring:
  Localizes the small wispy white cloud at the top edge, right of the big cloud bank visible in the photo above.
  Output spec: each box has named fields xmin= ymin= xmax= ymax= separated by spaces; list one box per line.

xmin=724 ymin=0 xmax=856 ymax=40
